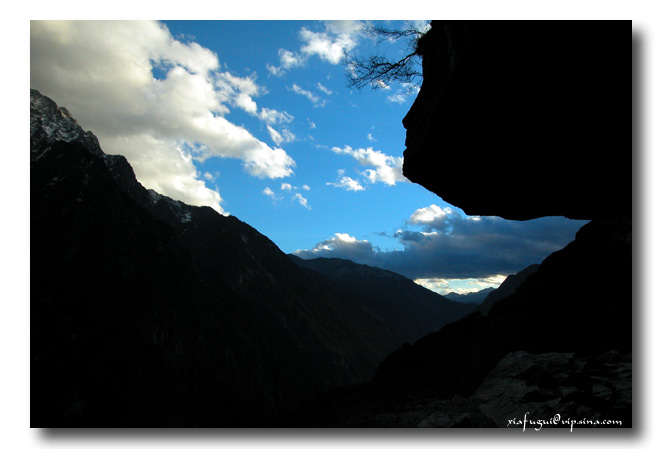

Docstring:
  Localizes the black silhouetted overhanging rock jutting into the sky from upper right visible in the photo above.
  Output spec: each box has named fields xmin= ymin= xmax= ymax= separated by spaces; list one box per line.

xmin=403 ymin=21 xmax=632 ymax=219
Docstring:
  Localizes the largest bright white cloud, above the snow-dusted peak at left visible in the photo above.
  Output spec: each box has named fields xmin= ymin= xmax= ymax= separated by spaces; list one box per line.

xmin=30 ymin=21 xmax=295 ymax=212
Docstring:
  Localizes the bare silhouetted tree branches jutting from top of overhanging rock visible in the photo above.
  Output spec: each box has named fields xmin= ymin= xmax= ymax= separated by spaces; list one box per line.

xmin=344 ymin=22 xmax=429 ymax=90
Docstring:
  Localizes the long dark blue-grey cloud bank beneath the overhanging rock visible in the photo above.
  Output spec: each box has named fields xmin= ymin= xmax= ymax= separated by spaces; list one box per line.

xmin=296 ymin=204 xmax=586 ymax=282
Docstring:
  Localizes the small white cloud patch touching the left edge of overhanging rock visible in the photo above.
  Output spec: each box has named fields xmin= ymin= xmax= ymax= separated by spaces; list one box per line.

xmin=331 ymin=146 xmax=409 ymax=186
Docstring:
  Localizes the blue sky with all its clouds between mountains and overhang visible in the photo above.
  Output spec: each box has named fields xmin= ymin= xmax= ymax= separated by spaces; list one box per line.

xmin=30 ymin=21 xmax=583 ymax=293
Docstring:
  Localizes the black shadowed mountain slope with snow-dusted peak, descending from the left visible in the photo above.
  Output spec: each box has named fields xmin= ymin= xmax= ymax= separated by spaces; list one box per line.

xmin=30 ymin=90 xmax=472 ymax=427
